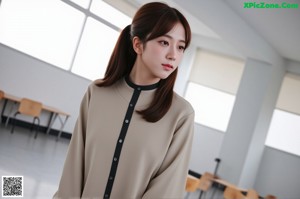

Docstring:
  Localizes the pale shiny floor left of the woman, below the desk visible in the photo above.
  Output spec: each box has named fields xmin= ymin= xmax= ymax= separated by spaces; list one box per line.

xmin=0 ymin=124 xmax=69 ymax=199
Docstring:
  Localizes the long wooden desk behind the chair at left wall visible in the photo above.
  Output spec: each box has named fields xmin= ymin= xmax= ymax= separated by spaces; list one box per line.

xmin=1 ymin=93 xmax=70 ymax=140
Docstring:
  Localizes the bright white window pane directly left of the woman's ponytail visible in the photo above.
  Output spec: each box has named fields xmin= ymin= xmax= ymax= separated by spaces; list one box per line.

xmin=72 ymin=17 xmax=119 ymax=80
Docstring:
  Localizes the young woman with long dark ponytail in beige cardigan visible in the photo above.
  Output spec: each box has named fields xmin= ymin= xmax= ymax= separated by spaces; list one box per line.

xmin=54 ymin=2 xmax=194 ymax=199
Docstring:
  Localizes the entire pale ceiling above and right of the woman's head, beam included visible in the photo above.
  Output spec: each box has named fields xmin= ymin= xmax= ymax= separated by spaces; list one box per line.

xmin=107 ymin=0 xmax=300 ymax=62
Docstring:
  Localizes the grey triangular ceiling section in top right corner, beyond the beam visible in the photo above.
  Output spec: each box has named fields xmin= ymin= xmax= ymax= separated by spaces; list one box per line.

xmin=226 ymin=0 xmax=300 ymax=62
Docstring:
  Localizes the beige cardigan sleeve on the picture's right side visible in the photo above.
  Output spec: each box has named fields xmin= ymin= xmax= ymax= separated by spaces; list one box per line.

xmin=143 ymin=112 xmax=194 ymax=199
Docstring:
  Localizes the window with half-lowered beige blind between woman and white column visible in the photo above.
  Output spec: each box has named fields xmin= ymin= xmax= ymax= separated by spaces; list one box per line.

xmin=185 ymin=49 xmax=244 ymax=132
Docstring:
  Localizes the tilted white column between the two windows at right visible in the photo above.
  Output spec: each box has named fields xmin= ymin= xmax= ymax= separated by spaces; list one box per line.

xmin=218 ymin=59 xmax=284 ymax=189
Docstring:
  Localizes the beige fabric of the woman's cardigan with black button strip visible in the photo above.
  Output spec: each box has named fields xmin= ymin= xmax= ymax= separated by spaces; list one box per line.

xmin=54 ymin=79 xmax=194 ymax=199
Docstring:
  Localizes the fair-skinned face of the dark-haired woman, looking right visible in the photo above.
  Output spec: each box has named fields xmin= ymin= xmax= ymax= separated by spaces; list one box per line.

xmin=136 ymin=23 xmax=185 ymax=83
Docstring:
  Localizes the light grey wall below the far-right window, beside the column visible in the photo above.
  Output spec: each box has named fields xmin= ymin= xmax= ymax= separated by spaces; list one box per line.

xmin=254 ymin=147 xmax=300 ymax=199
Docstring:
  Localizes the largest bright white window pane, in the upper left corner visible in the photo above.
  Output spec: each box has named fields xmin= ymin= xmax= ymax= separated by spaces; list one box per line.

xmin=0 ymin=0 xmax=84 ymax=70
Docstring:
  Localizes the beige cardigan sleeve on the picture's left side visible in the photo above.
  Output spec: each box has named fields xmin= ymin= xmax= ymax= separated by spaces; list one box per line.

xmin=53 ymin=86 xmax=90 ymax=199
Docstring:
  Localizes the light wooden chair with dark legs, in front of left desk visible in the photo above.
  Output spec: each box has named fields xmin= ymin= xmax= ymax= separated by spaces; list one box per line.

xmin=11 ymin=98 xmax=42 ymax=139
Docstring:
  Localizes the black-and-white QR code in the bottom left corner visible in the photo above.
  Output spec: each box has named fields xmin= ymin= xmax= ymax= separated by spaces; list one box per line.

xmin=2 ymin=176 xmax=23 ymax=198
